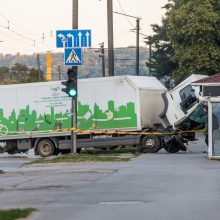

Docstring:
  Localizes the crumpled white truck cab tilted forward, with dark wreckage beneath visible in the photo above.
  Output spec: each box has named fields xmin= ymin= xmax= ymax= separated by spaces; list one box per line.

xmin=160 ymin=75 xmax=207 ymax=153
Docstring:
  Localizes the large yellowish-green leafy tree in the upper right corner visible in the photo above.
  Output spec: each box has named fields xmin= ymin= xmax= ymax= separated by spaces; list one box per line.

xmin=166 ymin=0 xmax=220 ymax=79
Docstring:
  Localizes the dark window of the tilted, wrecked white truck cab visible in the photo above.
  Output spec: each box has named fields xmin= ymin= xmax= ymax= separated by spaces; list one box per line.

xmin=179 ymin=85 xmax=197 ymax=112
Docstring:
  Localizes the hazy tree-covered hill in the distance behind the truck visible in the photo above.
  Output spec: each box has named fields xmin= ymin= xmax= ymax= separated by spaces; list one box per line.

xmin=0 ymin=47 xmax=149 ymax=80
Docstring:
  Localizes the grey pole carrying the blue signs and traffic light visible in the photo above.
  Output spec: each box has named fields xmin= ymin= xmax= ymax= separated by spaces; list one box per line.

xmin=71 ymin=0 xmax=78 ymax=154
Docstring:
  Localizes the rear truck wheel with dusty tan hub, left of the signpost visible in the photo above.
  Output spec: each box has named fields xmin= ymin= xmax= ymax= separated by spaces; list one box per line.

xmin=37 ymin=139 xmax=55 ymax=157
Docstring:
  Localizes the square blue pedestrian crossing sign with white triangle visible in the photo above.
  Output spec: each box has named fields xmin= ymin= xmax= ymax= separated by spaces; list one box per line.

xmin=64 ymin=48 xmax=82 ymax=66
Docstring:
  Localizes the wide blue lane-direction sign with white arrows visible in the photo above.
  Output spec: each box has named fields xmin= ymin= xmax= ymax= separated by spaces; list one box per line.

xmin=56 ymin=30 xmax=91 ymax=48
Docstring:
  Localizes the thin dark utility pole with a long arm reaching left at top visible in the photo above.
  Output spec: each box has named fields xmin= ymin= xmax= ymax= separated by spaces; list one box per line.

xmin=114 ymin=12 xmax=140 ymax=76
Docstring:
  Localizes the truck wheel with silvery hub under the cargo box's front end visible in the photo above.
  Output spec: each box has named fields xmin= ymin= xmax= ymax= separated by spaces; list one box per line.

xmin=139 ymin=135 xmax=161 ymax=153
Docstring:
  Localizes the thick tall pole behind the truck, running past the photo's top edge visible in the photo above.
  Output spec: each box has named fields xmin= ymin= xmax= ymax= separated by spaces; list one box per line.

xmin=107 ymin=0 xmax=114 ymax=76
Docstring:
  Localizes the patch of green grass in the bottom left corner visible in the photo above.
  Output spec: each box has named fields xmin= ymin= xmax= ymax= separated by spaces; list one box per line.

xmin=0 ymin=208 xmax=37 ymax=220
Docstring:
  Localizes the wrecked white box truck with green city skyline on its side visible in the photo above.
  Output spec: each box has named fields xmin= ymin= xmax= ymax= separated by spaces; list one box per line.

xmin=0 ymin=76 xmax=207 ymax=157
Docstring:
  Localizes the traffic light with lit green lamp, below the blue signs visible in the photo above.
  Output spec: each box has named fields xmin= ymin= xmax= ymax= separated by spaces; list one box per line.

xmin=61 ymin=69 xmax=77 ymax=98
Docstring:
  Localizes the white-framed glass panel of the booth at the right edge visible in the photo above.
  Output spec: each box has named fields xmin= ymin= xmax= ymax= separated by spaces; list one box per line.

xmin=208 ymin=97 xmax=220 ymax=159
